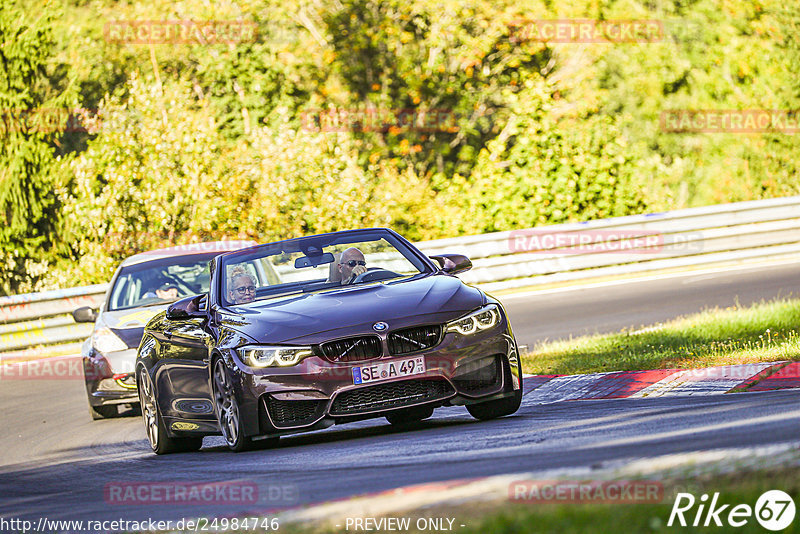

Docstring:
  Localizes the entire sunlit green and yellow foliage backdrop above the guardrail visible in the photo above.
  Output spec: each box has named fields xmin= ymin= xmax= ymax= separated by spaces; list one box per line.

xmin=0 ymin=0 xmax=800 ymax=292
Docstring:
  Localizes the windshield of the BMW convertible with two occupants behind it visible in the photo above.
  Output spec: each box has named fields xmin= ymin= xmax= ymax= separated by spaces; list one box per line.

xmin=220 ymin=231 xmax=430 ymax=305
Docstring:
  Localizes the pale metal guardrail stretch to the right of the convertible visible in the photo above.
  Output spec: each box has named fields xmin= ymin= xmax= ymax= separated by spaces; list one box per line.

xmin=419 ymin=196 xmax=800 ymax=291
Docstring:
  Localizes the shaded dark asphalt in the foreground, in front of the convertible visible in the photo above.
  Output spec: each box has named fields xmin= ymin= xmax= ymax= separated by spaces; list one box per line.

xmin=0 ymin=390 xmax=800 ymax=519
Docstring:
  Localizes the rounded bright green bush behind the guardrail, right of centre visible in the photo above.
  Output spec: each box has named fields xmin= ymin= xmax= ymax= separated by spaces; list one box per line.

xmin=434 ymin=82 xmax=647 ymax=237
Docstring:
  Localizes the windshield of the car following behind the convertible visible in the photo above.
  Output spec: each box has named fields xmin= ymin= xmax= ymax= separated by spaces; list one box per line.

xmin=108 ymin=252 xmax=219 ymax=311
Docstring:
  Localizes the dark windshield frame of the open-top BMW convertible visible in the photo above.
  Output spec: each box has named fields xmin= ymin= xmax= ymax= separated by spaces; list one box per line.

xmin=210 ymin=228 xmax=439 ymax=309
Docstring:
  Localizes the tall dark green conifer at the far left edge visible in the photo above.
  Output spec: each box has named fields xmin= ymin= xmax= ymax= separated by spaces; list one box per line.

xmin=0 ymin=0 xmax=75 ymax=293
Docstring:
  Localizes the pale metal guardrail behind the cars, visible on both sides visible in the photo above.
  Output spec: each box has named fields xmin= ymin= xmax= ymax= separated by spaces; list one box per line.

xmin=0 ymin=196 xmax=800 ymax=361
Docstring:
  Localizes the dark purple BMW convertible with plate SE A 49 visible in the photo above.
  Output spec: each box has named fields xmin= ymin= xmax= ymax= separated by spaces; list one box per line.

xmin=136 ymin=228 xmax=522 ymax=454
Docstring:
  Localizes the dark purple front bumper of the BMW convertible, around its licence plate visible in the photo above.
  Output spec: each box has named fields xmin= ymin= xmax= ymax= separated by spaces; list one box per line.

xmin=231 ymin=322 xmax=521 ymax=435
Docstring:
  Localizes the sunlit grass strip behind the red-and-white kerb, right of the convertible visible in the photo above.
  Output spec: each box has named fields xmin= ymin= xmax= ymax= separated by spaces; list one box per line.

xmin=522 ymin=299 xmax=800 ymax=374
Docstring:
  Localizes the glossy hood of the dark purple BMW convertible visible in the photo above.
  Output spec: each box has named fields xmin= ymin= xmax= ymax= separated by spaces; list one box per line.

xmin=222 ymin=275 xmax=486 ymax=343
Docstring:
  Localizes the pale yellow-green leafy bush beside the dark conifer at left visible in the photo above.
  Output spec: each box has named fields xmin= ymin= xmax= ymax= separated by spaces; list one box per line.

xmin=61 ymin=74 xmax=235 ymax=280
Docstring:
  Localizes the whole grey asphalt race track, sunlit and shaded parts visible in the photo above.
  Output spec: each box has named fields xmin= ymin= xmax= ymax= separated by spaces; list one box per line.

xmin=0 ymin=266 xmax=800 ymax=521
